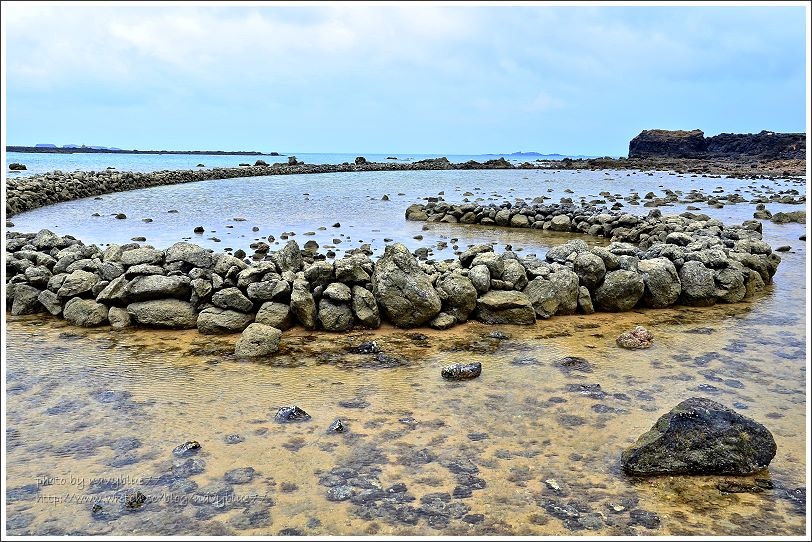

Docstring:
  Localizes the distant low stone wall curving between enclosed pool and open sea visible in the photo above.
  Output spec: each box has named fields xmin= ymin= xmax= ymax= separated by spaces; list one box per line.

xmin=6 ymin=156 xmax=512 ymax=217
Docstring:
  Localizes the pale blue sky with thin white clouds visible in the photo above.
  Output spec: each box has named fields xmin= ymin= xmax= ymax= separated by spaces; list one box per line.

xmin=2 ymin=2 xmax=808 ymax=156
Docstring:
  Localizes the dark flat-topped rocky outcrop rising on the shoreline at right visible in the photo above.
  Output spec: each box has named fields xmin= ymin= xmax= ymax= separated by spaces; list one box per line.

xmin=629 ymin=130 xmax=806 ymax=160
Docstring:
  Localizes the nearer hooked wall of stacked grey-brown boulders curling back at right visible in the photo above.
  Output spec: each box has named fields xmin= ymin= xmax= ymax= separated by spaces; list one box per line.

xmin=6 ymin=202 xmax=781 ymax=357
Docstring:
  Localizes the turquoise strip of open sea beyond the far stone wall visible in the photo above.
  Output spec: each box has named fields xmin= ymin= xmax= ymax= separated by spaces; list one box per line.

xmin=6 ymin=152 xmax=584 ymax=176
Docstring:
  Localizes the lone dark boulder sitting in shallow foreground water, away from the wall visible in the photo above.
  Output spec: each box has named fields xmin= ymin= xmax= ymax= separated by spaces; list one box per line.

xmin=621 ymin=397 xmax=777 ymax=476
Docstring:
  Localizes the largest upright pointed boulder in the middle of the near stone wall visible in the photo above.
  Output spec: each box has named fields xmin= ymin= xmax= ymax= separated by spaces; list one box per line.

xmin=372 ymin=243 xmax=442 ymax=327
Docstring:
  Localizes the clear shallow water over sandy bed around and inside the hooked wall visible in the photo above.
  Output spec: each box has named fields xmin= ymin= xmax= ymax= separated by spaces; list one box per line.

xmin=6 ymin=168 xmax=807 ymax=536
